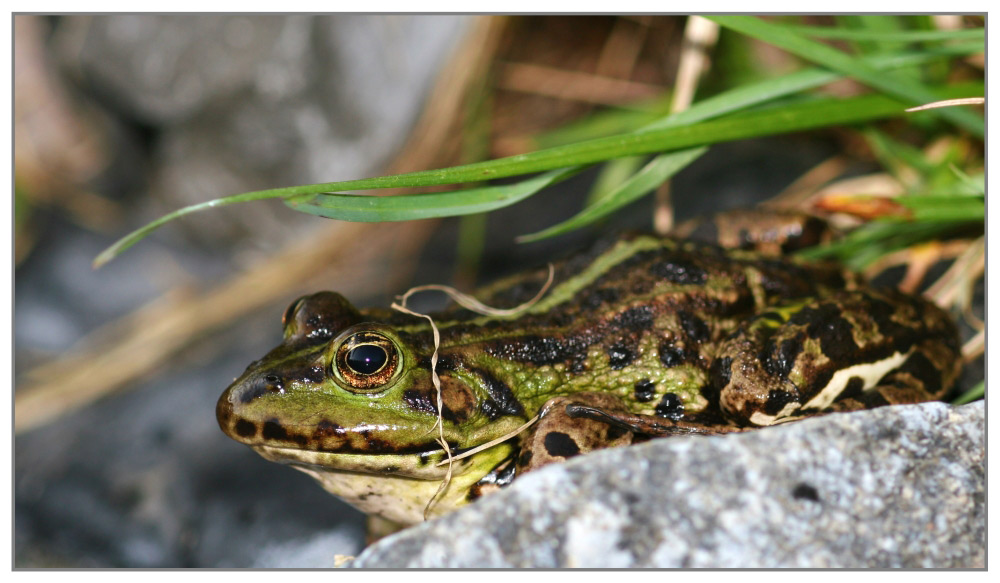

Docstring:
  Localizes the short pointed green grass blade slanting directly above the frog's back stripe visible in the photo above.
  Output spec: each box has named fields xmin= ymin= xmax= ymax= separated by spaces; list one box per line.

xmin=517 ymin=147 xmax=708 ymax=243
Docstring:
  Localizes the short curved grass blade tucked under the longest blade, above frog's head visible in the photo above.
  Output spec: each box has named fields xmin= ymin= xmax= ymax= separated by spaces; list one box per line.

xmin=285 ymin=167 xmax=582 ymax=223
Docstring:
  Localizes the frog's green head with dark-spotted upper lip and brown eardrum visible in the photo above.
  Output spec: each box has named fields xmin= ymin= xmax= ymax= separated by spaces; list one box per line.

xmin=216 ymin=292 xmax=525 ymax=479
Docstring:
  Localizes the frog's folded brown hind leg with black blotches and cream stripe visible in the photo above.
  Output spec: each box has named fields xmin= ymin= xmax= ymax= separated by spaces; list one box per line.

xmin=712 ymin=289 xmax=961 ymax=426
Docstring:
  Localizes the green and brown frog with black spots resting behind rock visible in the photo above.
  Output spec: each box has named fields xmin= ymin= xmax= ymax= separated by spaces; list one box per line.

xmin=216 ymin=213 xmax=961 ymax=525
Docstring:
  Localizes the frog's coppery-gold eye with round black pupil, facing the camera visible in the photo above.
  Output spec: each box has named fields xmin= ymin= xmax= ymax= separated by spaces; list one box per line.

xmin=333 ymin=332 xmax=399 ymax=391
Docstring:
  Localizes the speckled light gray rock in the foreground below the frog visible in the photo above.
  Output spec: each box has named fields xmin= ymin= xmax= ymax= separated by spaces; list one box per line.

xmin=352 ymin=402 xmax=986 ymax=568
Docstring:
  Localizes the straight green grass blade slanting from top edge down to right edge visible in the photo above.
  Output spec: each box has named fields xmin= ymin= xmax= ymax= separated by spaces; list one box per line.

xmin=707 ymin=15 xmax=986 ymax=138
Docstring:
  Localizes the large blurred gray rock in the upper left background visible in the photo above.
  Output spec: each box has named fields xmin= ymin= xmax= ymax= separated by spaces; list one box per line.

xmin=55 ymin=14 xmax=472 ymax=250
